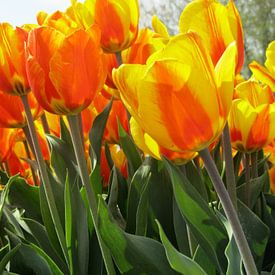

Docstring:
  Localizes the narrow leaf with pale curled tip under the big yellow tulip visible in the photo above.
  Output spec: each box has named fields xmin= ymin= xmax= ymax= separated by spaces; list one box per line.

xmin=126 ymin=162 xmax=150 ymax=233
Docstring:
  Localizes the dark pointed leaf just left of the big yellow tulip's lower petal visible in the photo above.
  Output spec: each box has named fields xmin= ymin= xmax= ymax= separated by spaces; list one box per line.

xmin=118 ymin=122 xmax=142 ymax=178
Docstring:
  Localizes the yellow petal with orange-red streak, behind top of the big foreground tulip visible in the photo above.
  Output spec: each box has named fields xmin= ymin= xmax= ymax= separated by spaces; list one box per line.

xmin=179 ymin=0 xmax=235 ymax=64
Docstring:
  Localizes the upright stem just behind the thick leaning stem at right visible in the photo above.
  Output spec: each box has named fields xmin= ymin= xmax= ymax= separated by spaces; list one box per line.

xmin=223 ymin=123 xmax=237 ymax=209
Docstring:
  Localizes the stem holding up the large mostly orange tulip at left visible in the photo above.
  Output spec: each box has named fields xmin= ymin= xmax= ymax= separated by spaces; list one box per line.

xmin=67 ymin=114 xmax=116 ymax=274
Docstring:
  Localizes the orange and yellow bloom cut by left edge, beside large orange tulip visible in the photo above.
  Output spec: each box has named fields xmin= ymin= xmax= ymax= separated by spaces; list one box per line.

xmin=0 ymin=23 xmax=30 ymax=96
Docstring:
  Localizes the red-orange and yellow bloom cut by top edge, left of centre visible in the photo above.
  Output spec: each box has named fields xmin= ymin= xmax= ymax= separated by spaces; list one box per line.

xmin=94 ymin=0 xmax=139 ymax=53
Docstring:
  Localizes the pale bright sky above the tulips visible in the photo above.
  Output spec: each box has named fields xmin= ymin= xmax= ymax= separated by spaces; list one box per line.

xmin=0 ymin=0 xmax=155 ymax=26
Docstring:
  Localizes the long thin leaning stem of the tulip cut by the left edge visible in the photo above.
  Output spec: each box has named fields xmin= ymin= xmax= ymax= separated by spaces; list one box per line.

xmin=21 ymin=95 xmax=69 ymax=264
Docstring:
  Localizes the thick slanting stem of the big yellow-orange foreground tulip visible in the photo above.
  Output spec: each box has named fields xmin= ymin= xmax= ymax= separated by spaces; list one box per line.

xmin=199 ymin=149 xmax=258 ymax=275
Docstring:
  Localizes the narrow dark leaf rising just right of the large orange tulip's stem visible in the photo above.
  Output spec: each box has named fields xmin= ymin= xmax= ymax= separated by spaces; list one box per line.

xmin=89 ymin=100 xmax=113 ymax=163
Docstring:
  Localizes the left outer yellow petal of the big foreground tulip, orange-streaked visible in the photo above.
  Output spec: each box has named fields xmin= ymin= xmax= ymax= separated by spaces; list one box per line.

xmin=112 ymin=64 xmax=147 ymax=122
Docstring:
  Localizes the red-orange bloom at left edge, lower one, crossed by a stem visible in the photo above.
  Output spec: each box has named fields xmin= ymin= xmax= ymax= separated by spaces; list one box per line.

xmin=0 ymin=91 xmax=42 ymax=128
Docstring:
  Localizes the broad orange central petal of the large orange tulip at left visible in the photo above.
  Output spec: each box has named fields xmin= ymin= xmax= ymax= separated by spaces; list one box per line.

xmin=50 ymin=26 xmax=106 ymax=114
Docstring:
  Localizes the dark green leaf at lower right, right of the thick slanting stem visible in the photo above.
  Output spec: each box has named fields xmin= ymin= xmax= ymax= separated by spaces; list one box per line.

xmin=238 ymin=200 xmax=270 ymax=270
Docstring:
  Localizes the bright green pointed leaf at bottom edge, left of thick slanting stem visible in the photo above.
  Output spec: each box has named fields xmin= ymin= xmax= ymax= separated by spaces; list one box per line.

xmin=157 ymin=221 xmax=206 ymax=275
